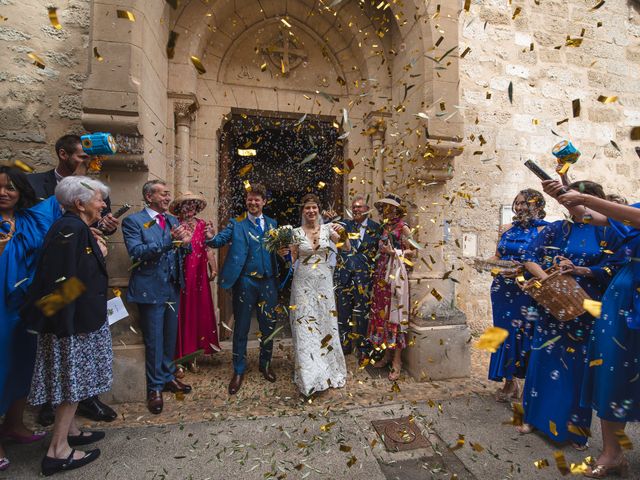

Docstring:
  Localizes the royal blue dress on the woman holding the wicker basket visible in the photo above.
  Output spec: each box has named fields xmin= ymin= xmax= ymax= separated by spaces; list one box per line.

xmin=522 ymin=220 xmax=621 ymax=445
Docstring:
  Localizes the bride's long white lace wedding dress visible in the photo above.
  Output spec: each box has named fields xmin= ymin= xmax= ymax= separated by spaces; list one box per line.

xmin=289 ymin=225 xmax=347 ymax=395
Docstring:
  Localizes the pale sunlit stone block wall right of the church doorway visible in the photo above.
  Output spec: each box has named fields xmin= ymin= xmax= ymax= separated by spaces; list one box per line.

xmin=447 ymin=0 xmax=640 ymax=330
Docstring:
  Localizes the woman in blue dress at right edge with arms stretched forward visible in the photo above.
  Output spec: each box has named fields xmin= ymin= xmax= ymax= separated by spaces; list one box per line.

xmin=543 ymin=180 xmax=640 ymax=478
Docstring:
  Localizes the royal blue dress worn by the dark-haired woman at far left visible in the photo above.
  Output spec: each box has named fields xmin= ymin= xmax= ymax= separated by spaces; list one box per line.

xmin=0 ymin=197 xmax=62 ymax=415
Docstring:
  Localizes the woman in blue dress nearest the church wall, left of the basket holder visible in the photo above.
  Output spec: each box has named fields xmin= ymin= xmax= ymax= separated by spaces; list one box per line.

xmin=489 ymin=189 xmax=547 ymax=402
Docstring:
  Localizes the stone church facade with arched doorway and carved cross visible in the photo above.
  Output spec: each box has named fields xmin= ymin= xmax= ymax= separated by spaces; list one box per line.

xmin=0 ymin=0 xmax=640 ymax=400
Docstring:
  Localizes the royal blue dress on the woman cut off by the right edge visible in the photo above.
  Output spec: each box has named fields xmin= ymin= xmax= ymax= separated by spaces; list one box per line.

xmin=582 ymin=204 xmax=640 ymax=422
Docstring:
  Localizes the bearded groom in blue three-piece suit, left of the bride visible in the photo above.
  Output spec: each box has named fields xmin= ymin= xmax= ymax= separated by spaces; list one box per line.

xmin=206 ymin=184 xmax=278 ymax=395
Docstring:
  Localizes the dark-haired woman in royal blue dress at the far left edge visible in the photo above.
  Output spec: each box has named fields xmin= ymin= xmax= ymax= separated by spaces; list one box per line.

xmin=0 ymin=167 xmax=61 ymax=471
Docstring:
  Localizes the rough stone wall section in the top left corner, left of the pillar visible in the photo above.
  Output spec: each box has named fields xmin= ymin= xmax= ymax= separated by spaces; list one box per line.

xmin=0 ymin=0 xmax=91 ymax=168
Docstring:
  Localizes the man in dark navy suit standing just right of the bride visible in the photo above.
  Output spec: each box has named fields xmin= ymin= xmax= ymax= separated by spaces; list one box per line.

xmin=334 ymin=195 xmax=382 ymax=354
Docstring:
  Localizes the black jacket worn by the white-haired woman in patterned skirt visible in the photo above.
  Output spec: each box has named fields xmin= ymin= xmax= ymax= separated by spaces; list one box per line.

xmin=20 ymin=212 xmax=108 ymax=337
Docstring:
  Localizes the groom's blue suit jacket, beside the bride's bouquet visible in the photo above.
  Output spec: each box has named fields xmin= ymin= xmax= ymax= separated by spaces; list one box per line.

xmin=206 ymin=215 xmax=278 ymax=289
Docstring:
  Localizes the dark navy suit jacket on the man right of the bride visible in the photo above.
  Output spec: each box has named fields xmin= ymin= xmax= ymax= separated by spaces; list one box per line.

xmin=335 ymin=219 xmax=382 ymax=286
